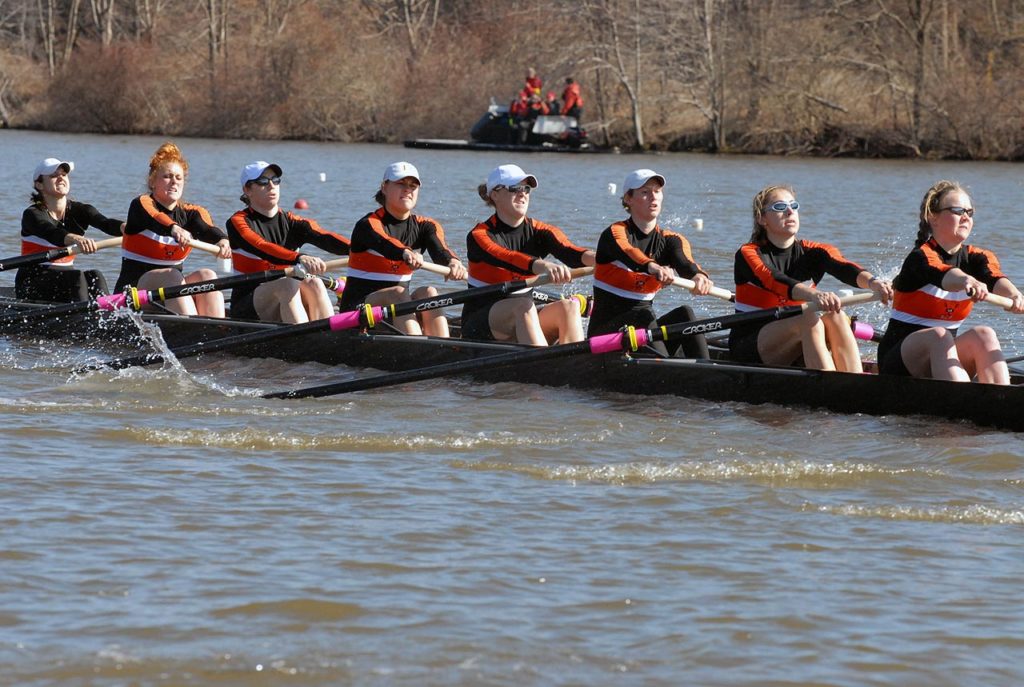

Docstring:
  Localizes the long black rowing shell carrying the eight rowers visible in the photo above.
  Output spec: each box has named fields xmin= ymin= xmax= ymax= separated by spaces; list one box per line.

xmin=0 ymin=286 xmax=1024 ymax=431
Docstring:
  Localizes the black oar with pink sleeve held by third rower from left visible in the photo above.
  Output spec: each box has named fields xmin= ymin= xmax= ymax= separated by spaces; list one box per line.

xmin=0 ymin=265 xmax=305 ymax=327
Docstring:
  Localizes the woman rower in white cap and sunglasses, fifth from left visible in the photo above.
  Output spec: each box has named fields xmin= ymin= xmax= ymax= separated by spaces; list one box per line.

xmin=462 ymin=165 xmax=594 ymax=346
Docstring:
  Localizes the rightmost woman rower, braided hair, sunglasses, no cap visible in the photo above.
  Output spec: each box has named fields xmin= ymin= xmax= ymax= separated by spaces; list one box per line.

xmin=879 ymin=181 xmax=1024 ymax=384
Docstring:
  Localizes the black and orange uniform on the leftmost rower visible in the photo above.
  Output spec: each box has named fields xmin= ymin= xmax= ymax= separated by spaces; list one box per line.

xmin=14 ymin=201 xmax=122 ymax=302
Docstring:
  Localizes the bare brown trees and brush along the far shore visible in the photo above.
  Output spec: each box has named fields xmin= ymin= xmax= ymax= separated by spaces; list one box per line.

xmin=0 ymin=0 xmax=1024 ymax=160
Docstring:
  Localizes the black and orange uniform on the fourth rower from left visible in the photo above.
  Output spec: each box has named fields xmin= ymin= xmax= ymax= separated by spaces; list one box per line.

xmin=340 ymin=208 xmax=457 ymax=310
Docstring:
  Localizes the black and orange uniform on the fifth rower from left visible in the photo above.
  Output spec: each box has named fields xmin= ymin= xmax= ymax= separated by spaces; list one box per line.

xmin=462 ymin=215 xmax=587 ymax=341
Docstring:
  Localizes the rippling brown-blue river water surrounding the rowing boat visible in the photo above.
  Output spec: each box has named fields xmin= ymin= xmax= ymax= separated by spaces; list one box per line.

xmin=0 ymin=131 xmax=1024 ymax=686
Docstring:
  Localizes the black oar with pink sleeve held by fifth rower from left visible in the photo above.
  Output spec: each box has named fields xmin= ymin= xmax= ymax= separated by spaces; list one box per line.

xmin=80 ymin=267 xmax=593 ymax=371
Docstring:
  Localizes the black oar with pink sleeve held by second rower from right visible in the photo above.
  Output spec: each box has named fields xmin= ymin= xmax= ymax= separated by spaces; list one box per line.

xmin=263 ymin=293 xmax=878 ymax=398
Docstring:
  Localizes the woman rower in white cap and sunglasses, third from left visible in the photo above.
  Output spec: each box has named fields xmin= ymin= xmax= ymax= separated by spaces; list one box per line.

xmin=227 ymin=161 xmax=348 ymax=325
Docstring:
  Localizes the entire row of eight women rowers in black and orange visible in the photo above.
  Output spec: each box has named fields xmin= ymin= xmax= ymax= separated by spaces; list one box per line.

xmin=17 ymin=143 xmax=1024 ymax=383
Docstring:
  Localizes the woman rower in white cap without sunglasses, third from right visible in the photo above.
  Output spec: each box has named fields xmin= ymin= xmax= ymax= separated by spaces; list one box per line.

xmin=587 ymin=169 xmax=714 ymax=358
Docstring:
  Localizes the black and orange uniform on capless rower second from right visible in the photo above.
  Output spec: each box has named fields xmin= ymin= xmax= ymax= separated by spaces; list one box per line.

xmin=729 ymin=239 xmax=863 ymax=363
